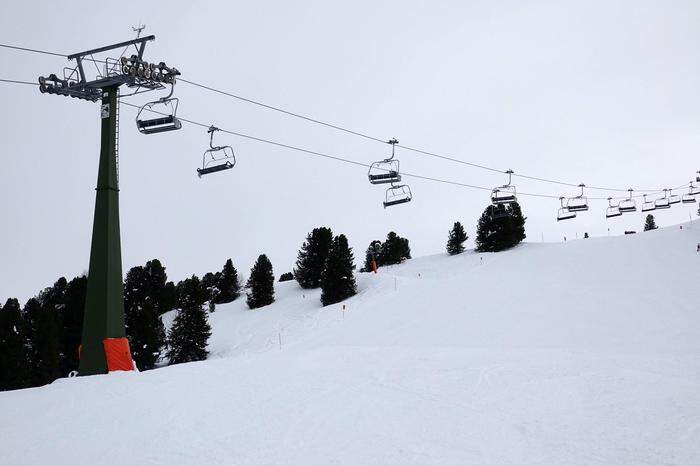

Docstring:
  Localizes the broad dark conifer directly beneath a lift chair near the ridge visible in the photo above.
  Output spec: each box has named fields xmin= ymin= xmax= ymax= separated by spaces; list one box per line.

xmin=476 ymin=202 xmax=526 ymax=252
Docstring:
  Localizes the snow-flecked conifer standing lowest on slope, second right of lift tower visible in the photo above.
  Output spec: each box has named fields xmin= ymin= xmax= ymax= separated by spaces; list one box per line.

xmin=167 ymin=275 xmax=211 ymax=364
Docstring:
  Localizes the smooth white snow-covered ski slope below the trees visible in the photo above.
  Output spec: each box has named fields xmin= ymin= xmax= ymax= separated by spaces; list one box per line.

xmin=0 ymin=222 xmax=700 ymax=466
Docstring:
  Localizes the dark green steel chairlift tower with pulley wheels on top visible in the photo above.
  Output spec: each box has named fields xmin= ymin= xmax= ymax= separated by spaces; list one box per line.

xmin=39 ymin=36 xmax=180 ymax=375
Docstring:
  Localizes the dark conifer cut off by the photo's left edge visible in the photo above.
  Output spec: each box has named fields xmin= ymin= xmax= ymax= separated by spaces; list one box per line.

xmin=0 ymin=298 xmax=30 ymax=391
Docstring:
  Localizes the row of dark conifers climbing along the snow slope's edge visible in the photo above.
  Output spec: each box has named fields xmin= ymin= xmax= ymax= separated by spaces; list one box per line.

xmin=0 ymin=200 xmax=525 ymax=390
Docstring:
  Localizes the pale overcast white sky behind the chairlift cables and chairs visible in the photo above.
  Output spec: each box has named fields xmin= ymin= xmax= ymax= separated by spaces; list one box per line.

xmin=0 ymin=1 xmax=700 ymax=301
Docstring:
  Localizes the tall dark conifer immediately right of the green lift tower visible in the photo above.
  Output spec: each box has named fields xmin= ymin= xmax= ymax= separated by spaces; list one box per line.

xmin=124 ymin=259 xmax=167 ymax=370
